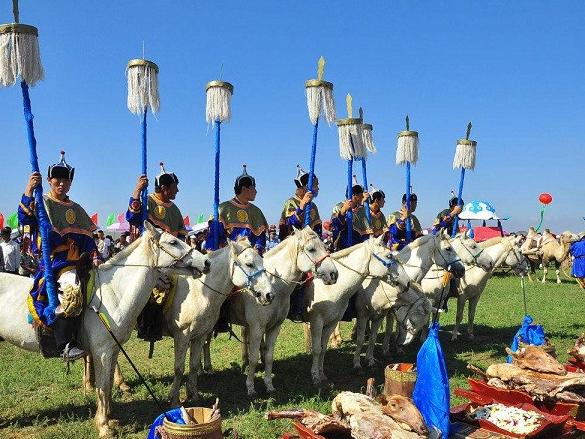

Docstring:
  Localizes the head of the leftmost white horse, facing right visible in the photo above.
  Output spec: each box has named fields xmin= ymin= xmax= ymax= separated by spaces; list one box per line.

xmin=142 ymin=221 xmax=211 ymax=277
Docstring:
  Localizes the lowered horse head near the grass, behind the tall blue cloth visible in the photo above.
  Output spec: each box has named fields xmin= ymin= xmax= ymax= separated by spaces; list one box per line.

xmin=393 ymin=288 xmax=433 ymax=346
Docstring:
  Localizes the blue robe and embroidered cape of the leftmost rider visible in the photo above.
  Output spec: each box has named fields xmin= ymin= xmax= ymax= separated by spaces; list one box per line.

xmin=18 ymin=193 xmax=99 ymax=326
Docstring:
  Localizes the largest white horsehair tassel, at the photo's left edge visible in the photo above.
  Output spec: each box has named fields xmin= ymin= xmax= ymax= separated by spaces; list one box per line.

xmin=0 ymin=23 xmax=45 ymax=87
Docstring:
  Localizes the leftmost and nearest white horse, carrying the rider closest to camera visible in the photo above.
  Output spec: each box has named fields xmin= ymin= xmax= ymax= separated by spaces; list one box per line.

xmin=0 ymin=222 xmax=210 ymax=437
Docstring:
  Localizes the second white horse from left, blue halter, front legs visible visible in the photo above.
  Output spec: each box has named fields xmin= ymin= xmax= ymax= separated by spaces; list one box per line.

xmin=165 ymin=238 xmax=274 ymax=406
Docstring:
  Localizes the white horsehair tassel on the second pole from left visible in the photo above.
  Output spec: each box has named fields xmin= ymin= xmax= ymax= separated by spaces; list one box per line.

xmin=126 ymin=59 xmax=160 ymax=114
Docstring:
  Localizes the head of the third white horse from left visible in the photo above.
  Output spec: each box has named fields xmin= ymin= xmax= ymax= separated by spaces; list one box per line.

xmin=293 ymin=226 xmax=339 ymax=285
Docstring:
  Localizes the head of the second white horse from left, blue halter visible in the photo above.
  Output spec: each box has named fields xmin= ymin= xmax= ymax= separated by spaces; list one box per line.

xmin=228 ymin=237 xmax=274 ymax=305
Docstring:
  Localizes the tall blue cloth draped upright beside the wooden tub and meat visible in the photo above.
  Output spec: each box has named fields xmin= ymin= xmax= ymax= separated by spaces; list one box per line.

xmin=412 ymin=322 xmax=451 ymax=438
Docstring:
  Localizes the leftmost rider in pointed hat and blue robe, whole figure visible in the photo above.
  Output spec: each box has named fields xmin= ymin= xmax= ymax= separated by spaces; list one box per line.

xmin=18 ymin=151 xmax=101 ymax=361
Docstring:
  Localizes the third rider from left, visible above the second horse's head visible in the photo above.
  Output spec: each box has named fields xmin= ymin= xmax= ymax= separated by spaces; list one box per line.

xmin=205 ymin=165 xmax=268 ymax=255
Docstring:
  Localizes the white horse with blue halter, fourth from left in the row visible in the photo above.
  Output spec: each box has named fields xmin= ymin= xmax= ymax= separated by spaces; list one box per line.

xmin=303 ymin=237 xmax=410 ymax=386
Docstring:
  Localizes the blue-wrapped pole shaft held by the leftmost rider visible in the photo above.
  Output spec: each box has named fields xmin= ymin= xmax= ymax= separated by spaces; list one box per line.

xmin=20 ymin=81 xmax=59 ymax=325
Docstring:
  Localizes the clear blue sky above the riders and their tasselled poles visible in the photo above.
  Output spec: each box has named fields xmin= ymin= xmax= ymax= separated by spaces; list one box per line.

xmin=0 ymin=0 xmax=585 ymax=231
